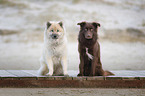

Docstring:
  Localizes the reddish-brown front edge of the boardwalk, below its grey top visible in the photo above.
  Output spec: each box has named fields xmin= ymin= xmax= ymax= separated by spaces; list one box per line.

xmin=0 ymin=77 xmax=145 ymax=88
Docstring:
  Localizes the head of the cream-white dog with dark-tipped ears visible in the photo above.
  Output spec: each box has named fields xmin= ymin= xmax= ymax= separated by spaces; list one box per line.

xmin=45 ymin=22 xmax=65 ymax=40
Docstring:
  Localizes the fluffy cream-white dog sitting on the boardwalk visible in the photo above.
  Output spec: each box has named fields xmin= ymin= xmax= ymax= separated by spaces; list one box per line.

xmin=38 ymin=22 xmax=68 ymax=76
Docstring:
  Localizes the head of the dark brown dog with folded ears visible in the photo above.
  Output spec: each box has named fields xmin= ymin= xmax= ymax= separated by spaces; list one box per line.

xmin=77 ymin=22 xmax=100 ymax=40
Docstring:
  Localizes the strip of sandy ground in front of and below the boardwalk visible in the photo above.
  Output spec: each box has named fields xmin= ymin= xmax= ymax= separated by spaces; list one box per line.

xmin=0 ymin=88 xmax=145 ymax=96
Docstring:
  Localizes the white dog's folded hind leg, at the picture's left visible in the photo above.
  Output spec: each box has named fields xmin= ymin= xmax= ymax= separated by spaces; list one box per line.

xmin=38 ymin=57 xmax=48 ymax=75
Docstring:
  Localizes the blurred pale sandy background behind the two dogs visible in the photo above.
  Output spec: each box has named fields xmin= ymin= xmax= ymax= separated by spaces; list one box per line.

xmin=0 ymin=0 xmax=145 ymax=70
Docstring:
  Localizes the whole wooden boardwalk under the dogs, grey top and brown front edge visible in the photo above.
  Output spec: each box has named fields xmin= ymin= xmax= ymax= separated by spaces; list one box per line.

xmin=0 ymin=70 xmax=145 ymax=88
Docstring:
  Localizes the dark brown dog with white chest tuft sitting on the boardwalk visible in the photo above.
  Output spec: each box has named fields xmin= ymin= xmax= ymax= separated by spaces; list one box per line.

xmin=77 ymin=22 xmax=114 ymax=76
